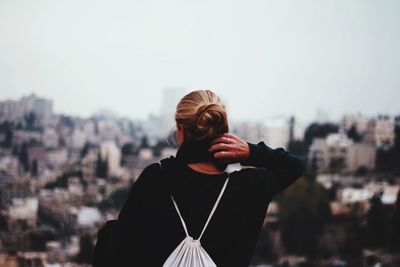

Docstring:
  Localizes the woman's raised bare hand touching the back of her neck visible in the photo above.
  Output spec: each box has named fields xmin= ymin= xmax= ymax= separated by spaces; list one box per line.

xmin=208 ymin=133 xmax=250 ymax=164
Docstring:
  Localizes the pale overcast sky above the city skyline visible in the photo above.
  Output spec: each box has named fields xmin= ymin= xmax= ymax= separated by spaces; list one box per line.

xmin=0 ymin=0 xmax=400 ymax=125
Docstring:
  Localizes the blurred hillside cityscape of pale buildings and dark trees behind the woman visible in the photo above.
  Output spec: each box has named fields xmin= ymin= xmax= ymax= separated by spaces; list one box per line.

xmin=0 ymin=90 xmax=400 ymax=267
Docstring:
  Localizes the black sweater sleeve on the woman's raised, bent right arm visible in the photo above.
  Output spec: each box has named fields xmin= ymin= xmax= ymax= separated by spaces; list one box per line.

xmin=240 ymin=141 xmax=305 ymax=197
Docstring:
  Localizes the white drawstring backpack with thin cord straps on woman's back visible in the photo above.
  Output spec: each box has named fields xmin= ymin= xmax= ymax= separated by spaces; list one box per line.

xmin=163 ymin=164 xmax=229 ymax=267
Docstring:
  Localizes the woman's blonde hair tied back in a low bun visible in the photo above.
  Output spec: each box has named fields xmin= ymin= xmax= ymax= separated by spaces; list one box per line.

xmin=175 ymin=90 xmax=229 ymax=140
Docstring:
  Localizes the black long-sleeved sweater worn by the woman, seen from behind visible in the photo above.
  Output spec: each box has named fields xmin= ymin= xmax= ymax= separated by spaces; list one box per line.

xmin=116 ymin=142 xmax=305 ymax=267
